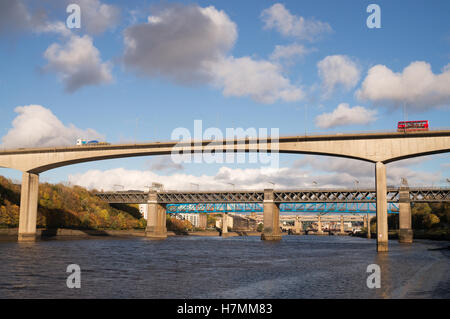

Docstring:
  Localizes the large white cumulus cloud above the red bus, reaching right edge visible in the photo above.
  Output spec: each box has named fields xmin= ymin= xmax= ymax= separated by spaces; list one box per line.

xmin=356 ymin=61 xmax=450 ymax=110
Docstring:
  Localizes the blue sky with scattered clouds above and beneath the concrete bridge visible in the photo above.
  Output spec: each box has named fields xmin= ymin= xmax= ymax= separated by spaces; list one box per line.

xmin=0 ymin=0 xmax=450 ymax=190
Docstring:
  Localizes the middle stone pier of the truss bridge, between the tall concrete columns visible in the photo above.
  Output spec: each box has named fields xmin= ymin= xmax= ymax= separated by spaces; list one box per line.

xmin=261 ymin=189 xmax=281 ymax=240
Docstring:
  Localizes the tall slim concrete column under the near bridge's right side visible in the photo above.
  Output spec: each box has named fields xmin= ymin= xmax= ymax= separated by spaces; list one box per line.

xmin=375 ymin=162 xmax=388 ymax=252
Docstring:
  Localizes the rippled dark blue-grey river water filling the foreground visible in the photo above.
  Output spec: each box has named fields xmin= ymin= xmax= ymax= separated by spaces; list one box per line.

xmin=0 ymin=236 xmax=450 ymax=298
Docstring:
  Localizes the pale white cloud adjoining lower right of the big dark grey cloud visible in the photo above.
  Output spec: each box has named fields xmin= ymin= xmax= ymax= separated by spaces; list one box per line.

xmin=211 ymin=57 xmax=304 ymax=103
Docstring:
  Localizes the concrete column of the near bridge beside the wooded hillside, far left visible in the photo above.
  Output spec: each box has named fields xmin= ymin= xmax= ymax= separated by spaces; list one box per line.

xmin=18 ymin=172 xmax=39 ymax=242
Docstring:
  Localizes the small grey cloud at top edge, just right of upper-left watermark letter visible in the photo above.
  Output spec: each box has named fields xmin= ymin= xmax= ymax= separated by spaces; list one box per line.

xmin=68 ymin=0 xmax=120 ymax=34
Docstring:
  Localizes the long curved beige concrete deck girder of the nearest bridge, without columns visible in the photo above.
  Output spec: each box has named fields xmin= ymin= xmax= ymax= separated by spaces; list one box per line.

xmin=0 ymin=130 xmax=450 ymax=174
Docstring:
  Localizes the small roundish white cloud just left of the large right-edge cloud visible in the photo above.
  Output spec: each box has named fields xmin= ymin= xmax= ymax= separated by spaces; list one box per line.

xmin=317 ymin=55 xmax=361 ymax=95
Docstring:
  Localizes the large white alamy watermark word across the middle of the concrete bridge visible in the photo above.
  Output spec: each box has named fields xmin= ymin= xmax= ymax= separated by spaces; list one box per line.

xmin=171 ymin=120 xmax=280 ymax=168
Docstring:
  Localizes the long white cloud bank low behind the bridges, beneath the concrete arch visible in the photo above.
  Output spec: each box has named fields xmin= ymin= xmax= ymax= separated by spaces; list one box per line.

xmin=69 ymin=156 xmax=442 ymax=191
